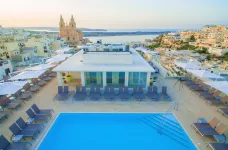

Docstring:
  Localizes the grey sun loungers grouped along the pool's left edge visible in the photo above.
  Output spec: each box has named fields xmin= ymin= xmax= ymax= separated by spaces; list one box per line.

xmin=0 ymin=104 xmax=54 ymax=150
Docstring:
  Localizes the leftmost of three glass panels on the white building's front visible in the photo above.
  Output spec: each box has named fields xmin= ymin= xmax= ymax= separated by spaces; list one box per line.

xmin=85 ymin=72 xmax=103 ymax=87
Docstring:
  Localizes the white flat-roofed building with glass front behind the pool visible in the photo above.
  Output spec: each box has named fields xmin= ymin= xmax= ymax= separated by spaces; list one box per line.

xmin=54 ymin=46 xmax=154 ymax=88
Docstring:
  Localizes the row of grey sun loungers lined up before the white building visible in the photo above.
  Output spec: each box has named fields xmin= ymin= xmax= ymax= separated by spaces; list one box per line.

xmin=55 ymin=86 xmax=169 ymax=100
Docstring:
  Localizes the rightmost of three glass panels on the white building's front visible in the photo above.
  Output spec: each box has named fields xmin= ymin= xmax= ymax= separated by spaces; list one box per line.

xmin=128 ymin=72 xmax=147 ymax=87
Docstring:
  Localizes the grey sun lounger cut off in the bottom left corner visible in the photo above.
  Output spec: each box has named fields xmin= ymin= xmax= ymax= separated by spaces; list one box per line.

xmin=0 ymin=135 xmax=30 ymax=150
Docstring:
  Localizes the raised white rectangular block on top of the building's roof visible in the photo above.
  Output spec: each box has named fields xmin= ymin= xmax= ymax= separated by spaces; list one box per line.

xmin=83 ymin=52 xmax=133 ymax=64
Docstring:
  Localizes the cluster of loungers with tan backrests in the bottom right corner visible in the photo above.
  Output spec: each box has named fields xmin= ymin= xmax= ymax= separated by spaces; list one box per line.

xmin=192 ymin=117 xmax=228 ymax=150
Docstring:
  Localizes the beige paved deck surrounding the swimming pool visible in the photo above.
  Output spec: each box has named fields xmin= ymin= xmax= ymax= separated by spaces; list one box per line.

xmin=0 ymin=76 xmax=228 ymax=150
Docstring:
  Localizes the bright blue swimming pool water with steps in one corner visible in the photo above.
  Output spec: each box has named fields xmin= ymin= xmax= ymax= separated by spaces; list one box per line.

xmin=38 ymin=113 xmax=196 ymax=150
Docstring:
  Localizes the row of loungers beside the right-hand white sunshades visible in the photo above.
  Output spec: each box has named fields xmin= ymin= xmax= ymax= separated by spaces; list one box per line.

xmin=184 ymin=76 xmax=228 ymax=116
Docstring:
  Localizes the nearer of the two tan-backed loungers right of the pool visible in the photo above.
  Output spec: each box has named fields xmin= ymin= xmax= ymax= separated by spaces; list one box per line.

xmin=194 ymin=123 xmax=228 ymax=138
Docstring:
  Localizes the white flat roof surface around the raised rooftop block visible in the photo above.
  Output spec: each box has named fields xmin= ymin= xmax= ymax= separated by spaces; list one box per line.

xmin=53 ymin=48 xmax=154 ymax=72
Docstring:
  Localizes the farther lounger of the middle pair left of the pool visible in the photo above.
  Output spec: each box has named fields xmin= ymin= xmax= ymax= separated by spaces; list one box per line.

xmin=16 ymin=117 xmax=44 ymax=131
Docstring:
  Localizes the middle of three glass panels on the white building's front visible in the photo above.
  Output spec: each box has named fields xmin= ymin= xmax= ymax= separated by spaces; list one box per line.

xmin=106 ymin=72 xmax=125 ymax=86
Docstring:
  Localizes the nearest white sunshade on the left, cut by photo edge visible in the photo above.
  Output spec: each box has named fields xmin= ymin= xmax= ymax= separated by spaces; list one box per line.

xmin=0 ymin=81 xmax=28 ymax=95
